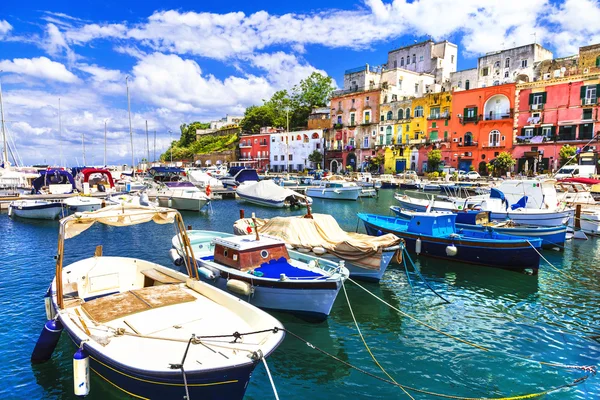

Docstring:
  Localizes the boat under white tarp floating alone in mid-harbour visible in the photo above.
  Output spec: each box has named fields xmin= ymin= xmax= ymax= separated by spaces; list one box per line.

xmin=236 ymin=180 xmax=312 ymax=208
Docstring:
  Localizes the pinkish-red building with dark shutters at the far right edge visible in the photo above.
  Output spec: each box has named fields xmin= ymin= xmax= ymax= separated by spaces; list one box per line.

xmin=513 ymin=72 xmax=600 ymax=174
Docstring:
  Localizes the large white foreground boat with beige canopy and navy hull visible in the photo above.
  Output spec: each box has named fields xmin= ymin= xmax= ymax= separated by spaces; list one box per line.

xmin=32 ymin=205 xmax=284 ymax=400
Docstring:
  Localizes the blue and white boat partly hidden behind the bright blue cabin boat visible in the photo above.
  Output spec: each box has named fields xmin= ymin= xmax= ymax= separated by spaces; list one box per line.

xmin=390 ymin=206 xmax=567 ymax=249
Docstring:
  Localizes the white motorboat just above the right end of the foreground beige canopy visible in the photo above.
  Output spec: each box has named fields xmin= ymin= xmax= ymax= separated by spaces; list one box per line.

xmin=148 ymin=181 xmax=210 ymax=211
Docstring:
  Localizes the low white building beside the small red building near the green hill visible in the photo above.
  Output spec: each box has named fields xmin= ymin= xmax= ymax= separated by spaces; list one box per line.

xmin=270 ymin=129 xmax=323 ymax=172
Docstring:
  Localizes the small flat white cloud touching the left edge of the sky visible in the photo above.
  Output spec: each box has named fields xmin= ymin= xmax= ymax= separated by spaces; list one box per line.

xmin=0 ymin=57 xmax=79 ymax=83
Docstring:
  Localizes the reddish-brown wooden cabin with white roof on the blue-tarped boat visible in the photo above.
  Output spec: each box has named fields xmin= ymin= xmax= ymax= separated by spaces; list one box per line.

xmin=213 ymin=235 xmax=290 ymax=271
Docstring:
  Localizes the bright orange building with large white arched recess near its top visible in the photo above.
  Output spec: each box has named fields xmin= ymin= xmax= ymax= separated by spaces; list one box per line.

xmin=450 ymin=83 xmax=515 ymax=175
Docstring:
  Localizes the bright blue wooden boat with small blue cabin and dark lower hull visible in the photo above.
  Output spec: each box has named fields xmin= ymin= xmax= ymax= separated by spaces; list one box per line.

xmin=358 ymin=212 xmax=542 ymax=273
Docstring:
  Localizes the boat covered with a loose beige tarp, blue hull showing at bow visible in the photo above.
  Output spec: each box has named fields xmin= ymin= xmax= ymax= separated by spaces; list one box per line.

xmin=233 ymin=214 xmax=402 ymax=282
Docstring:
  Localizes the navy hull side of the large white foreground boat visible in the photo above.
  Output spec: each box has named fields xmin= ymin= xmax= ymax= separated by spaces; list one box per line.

xmin=59 ymin=314 xmax=256 ymax=400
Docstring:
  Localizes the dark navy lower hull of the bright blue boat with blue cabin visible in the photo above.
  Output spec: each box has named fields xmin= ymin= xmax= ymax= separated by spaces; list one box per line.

xmin=363 ymin=221 xmax=540 ymax=271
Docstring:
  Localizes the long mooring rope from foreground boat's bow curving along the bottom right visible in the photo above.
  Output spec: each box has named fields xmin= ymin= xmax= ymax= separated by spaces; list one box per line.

xmin=282 ymin=329 xmax=589 ymax=400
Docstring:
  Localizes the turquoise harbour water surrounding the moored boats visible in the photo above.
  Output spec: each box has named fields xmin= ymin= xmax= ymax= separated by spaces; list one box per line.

xmin=0 ymin=190 xmax=600 ymax=400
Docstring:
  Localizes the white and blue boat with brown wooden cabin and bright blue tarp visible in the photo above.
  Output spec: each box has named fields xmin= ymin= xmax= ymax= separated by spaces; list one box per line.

xmin=172 ymin=231 xmax=349 ymax=321
